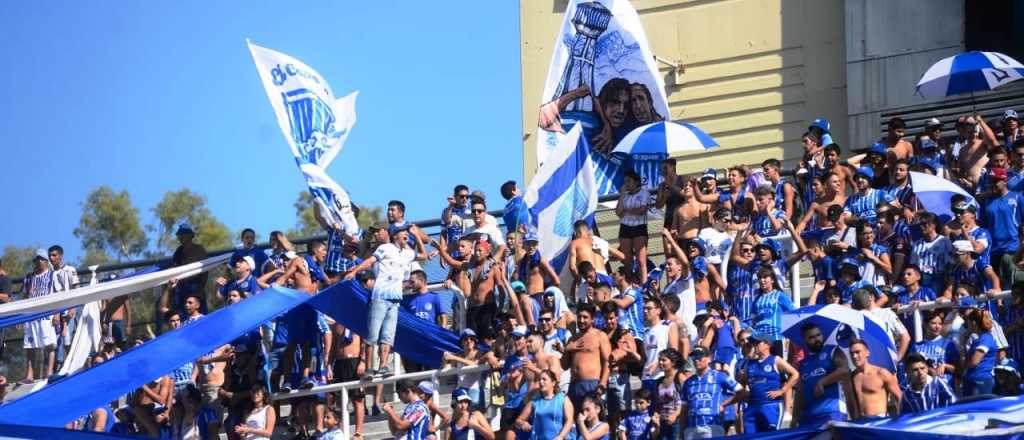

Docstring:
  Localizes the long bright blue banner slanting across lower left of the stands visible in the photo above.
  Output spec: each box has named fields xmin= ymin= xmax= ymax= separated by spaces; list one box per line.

xmin=0 ymin=288 xmax=310 ymax=428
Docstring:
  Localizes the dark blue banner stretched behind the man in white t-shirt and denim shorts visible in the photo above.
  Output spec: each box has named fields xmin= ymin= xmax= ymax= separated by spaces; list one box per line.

xmin=309 ymin=281 xmax=462 ymax=368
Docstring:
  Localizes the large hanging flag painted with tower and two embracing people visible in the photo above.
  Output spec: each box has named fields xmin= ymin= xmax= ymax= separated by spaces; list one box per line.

xmin=537 ymin=0 xmax=669 ymax=195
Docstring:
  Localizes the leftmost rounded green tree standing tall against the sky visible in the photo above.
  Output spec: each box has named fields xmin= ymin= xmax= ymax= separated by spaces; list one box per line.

xmin=75 ymin=186 xmax=146 ymax=261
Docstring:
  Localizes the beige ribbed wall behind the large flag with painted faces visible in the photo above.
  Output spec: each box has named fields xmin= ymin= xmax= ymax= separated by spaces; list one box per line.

xmin=520 ymin=0 xmax=847 ymax=181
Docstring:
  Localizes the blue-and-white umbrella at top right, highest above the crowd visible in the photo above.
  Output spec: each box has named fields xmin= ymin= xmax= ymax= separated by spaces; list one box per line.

xmin=918 ymin=51 xmax=1024 ymax=98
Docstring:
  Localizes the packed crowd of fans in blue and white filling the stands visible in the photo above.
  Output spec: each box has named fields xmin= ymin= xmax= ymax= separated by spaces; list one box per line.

xmin=6 ymin=109 xmax=1024 ymax=440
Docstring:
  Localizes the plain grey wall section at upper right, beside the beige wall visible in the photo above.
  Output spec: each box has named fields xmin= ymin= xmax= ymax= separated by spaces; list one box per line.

xmin=845 ymin=0 xmax=964 ymax=148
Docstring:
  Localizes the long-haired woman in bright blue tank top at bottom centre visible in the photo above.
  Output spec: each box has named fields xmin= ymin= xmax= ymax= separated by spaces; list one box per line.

xmin=516 ymin=369 xmax=574 ymax=440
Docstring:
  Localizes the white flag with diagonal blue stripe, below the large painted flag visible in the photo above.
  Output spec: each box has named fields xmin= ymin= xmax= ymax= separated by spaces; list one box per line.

xmin=523 ymin=124 xmax=597 ymax=273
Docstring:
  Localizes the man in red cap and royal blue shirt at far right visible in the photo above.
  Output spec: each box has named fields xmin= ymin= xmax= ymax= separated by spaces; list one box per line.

xmin=981 ymin=164 xmax=1024 ymax=278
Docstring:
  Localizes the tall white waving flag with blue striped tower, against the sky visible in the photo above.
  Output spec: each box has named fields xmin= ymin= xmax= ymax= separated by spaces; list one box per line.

xmin=247 ymin=42 xmax=359 ymax=236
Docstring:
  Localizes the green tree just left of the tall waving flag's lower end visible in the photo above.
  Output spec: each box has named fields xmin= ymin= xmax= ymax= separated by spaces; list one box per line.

xmin=152 ymin=188 xmax=231 ymax=250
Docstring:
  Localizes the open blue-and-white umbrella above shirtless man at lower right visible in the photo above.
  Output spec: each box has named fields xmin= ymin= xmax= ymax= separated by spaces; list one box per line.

xmin=782 ymin=304 xmax=897 ymax=372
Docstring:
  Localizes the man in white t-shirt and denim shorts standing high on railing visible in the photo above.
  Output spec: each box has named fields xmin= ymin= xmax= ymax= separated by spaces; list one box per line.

xmin=345 ymin=225 xmax=427 ymax=377
